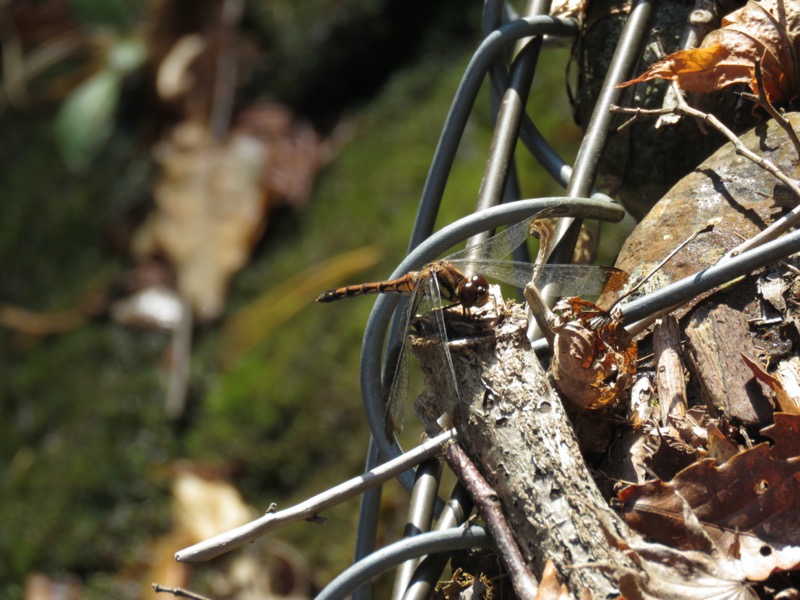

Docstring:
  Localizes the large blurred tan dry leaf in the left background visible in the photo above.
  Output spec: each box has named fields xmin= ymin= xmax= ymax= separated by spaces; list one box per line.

xmin=133 ymin=122 xmax=267 ymax=320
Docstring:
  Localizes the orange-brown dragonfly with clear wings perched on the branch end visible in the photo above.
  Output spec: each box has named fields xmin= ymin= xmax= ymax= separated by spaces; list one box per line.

xmin=317 ymin=212 xmax=628 ymax=440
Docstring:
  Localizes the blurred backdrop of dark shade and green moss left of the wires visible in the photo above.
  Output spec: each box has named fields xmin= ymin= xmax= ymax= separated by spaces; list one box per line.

xmin=0 ymin=0 xmax=580 ymax=600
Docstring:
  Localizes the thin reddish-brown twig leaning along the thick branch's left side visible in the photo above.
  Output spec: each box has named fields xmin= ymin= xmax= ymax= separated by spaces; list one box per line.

xmin=444 ymin=441 xmax=539 ymax=598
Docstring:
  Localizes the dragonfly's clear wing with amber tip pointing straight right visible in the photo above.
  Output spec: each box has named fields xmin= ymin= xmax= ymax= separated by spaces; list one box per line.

xmin=451 ymin=259 xmax=628 ymax=297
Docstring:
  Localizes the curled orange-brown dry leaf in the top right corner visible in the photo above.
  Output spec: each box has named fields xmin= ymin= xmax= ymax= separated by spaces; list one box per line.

xmin=622 ymin=0 xmax=800 ymax=102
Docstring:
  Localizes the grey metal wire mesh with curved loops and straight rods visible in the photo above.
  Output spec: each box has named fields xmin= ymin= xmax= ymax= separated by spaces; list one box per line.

xmin=304 ymin=0 xmax=800 ymax=599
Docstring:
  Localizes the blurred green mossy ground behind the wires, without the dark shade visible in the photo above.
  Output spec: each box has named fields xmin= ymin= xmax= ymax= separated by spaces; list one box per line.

xmin=0 ymin=17 xmax=578 ymax=599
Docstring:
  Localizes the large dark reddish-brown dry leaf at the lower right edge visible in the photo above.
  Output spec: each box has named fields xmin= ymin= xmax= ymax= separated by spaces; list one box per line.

xmin=619 ymin=413 xmax=800 ymax=581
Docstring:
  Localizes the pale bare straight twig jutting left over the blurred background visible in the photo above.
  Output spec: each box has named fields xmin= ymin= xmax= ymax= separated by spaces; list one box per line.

xmin=175 ymin=429 xmax=456 ymax=562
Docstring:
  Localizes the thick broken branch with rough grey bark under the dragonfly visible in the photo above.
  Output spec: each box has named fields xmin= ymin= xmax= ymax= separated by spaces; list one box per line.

xmin=414 ymin=305 xmax=634 ymax=598
